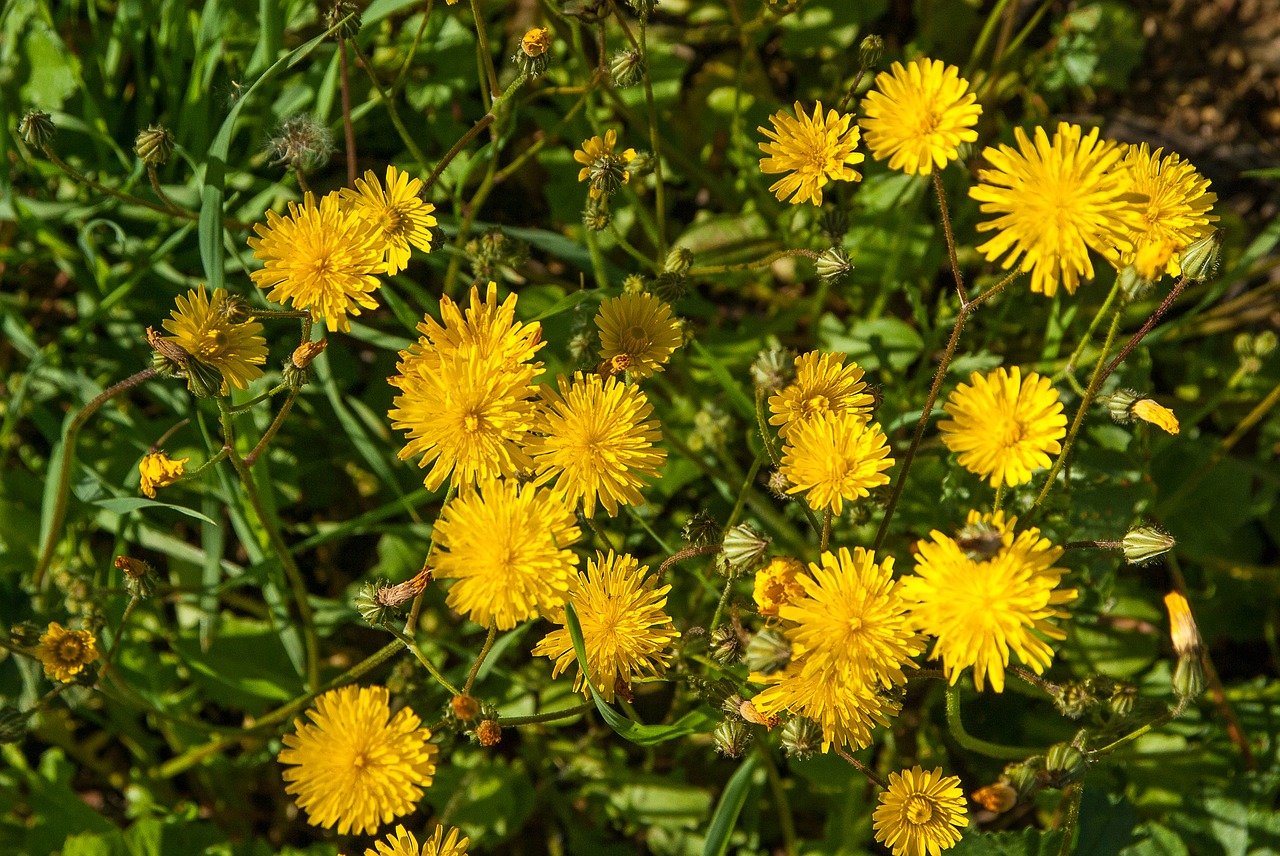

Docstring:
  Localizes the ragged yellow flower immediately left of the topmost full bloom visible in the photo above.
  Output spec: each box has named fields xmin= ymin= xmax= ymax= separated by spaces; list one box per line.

xmin=756 ymin=101 xmax=867 ymax=205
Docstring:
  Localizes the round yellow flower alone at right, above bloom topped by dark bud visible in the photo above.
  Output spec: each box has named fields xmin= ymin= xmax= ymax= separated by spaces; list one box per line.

xmin=938 ymin=366 xmax=1066 ymax=487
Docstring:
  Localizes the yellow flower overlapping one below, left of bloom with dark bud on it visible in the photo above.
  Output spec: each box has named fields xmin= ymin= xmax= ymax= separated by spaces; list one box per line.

xmin=778 ymin=546 xmax=924 ymax=688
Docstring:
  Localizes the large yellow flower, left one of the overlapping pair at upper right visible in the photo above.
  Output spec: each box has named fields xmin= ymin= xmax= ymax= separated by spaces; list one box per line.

xmin=969 ymin=122 xmax=1143 ymax=297
